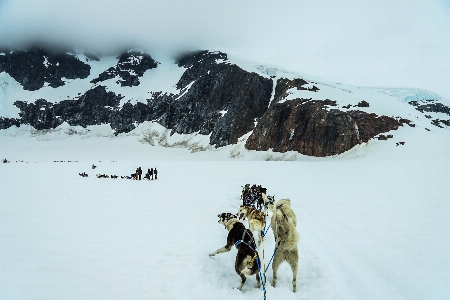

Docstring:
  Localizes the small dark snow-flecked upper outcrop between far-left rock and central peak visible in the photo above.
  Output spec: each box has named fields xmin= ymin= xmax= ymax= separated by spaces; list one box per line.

xmin=91 ymin=51 xmax=158 ymax=86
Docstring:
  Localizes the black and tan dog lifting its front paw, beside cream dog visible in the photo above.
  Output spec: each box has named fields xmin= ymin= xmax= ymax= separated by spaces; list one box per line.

xmin=209 ymin=213 xmax=261 ymax=290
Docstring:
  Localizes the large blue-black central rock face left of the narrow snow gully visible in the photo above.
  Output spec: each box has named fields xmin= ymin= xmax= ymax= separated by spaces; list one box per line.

xmin=160 ymin=51 xmax=272 ymax=147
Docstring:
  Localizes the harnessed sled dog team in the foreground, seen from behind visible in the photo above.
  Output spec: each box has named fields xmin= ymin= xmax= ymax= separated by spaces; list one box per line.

xmin=209 ymin=185 xmax=299 ymax=292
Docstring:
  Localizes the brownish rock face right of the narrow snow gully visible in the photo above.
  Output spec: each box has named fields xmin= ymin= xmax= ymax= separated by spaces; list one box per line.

xmin=245 ymin=99 xmax=402 ymax=157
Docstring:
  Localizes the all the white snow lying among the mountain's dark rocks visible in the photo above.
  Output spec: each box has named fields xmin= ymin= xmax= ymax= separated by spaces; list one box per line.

xmin=0 ymin=50 xmax=449 ymax=160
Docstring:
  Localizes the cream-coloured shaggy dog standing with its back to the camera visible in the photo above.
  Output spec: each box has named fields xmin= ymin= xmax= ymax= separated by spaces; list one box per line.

xmin=270 ymin=199 xmax=299 ymax=293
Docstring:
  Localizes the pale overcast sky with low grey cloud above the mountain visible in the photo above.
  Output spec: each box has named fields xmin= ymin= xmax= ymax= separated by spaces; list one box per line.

xmin=0 ymin=0 xmax=450 ymax=99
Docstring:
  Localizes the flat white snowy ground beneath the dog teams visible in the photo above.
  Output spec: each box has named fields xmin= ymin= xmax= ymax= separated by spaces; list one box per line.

xmin=0 ymin=122 xmax=450 ymax=300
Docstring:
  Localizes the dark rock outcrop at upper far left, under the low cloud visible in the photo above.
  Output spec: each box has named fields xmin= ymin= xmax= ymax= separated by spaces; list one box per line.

xmin=0 ymin=48 xmax=91 ymax=91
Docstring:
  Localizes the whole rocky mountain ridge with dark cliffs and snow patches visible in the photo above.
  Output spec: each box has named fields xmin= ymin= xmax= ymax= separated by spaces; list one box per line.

xmin=0 ymin=47 xmax=450 ymax=157
